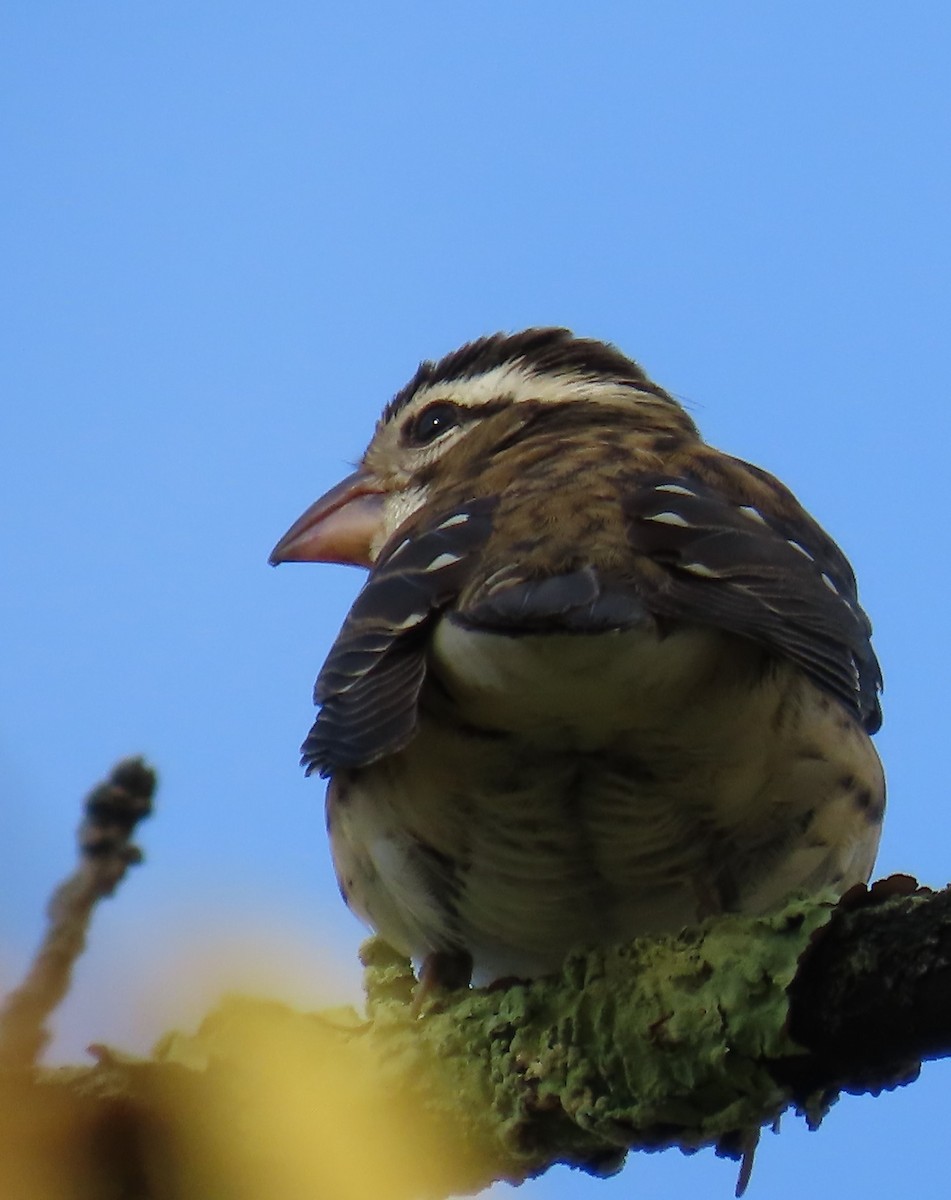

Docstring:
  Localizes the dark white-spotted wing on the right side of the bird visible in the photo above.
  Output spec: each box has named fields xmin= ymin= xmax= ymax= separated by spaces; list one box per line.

xmin=623 ymin=460 xmax=881 ymax=733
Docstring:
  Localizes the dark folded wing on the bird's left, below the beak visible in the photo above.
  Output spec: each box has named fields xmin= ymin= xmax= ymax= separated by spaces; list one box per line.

xmin=301 ymin=499 xmax=495 ymax=775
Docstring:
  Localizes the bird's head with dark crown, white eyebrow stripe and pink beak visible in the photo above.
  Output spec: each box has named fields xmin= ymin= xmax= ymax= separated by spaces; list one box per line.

xmin=270 ymin=329 xmax=696 ymax=566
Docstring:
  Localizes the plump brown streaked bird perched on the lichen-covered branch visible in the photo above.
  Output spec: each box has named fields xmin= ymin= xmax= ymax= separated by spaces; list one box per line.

xmin=270 ymin=328 xmax=885 ymax=991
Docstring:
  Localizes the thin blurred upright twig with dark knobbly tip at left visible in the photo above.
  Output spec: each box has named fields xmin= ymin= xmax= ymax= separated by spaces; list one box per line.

xmin=0 ymin=758 xmax=155 ymax=1067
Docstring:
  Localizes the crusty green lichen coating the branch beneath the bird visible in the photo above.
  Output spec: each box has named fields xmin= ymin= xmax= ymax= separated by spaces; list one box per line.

xmin=364 ymin=896 xmax=833 ymax=1178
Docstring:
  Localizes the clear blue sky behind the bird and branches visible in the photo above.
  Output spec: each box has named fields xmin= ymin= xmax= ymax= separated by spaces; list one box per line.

xmin=0 ymin=0 xmax=951 ymax=1200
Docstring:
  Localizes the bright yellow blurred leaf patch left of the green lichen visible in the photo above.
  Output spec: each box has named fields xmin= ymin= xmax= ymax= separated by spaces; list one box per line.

xmin=162 ymin=1001 xmax=475 ymax=1200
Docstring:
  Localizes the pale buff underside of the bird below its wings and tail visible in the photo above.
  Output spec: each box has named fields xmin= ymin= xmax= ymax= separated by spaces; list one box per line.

xmin=328 ymin=622 xmax=884 ymax=979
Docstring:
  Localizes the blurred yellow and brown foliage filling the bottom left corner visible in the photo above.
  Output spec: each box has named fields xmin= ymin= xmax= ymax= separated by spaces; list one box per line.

xmin=0 ymin=1000 xmax=472 ymax=1200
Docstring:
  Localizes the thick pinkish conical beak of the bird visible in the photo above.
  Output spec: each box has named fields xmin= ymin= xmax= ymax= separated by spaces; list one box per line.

xmin=268 ymin=470 xmax=383 ymax=566
